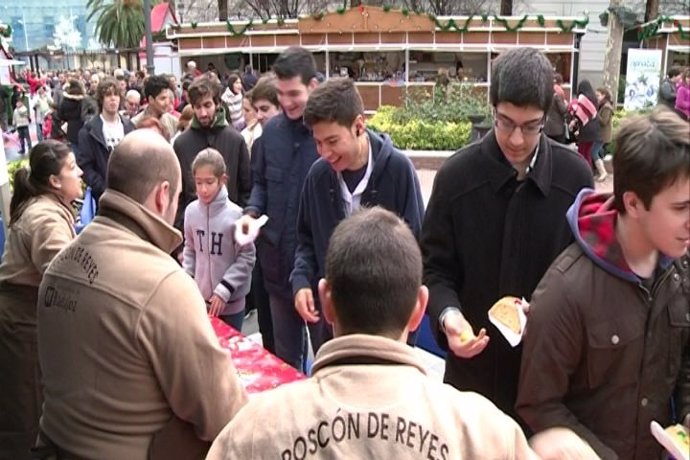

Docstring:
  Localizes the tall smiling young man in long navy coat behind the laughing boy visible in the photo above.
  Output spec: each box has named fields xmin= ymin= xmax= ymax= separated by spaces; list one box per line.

xmin=237 ymin=47 xmax=319 ymax=369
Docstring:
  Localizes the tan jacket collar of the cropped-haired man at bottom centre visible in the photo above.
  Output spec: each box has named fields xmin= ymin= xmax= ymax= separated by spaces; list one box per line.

xmin=312 ymin=334 xmax=426 ymax=375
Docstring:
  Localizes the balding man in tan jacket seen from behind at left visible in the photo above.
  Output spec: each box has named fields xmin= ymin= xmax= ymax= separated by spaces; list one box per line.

xmin=38 ymin=130 xmax=247 ymax=460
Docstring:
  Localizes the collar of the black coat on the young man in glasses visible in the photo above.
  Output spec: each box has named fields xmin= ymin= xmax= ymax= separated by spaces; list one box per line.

xmin=480 ymin=129 xmax=551 ymax=196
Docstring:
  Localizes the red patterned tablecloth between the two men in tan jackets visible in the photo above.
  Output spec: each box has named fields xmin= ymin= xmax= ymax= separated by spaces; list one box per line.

xmin=211 ymin=318 xmax=305 ymax=393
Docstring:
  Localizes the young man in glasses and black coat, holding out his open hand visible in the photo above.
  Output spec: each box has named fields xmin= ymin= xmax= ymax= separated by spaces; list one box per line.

xmin=421 ymin=48 xmax=593 ymax=415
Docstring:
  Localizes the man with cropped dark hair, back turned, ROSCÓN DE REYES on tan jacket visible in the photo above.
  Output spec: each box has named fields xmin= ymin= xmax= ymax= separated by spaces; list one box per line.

xmin=207 ymin=208 xmax=596 ymax=460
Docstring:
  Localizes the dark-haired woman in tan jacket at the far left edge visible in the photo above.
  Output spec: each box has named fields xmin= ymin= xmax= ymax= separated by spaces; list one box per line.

xmin=0 ymin=140 xmax=82 ymax=460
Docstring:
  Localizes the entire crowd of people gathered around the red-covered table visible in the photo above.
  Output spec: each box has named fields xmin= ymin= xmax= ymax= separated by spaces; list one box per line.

xmin=0 ymin=47 xmax=690 ymax=460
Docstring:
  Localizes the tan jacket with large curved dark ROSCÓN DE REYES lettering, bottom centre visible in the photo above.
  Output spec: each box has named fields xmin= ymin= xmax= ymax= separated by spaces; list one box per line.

xmin=206 ymin=335 xmax=538 ymax=460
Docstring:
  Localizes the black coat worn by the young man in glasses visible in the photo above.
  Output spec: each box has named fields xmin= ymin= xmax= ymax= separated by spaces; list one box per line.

xmin=421 ymin=131 xmax=593 ymax=414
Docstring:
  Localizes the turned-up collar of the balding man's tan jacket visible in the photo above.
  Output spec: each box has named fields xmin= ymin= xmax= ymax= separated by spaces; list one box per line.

xmin=96 ymin=189 xmax=182 ymax=254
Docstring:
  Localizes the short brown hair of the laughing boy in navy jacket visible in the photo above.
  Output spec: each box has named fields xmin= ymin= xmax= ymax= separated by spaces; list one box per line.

xmin=304 ymin=78 xmax=364 ymax=128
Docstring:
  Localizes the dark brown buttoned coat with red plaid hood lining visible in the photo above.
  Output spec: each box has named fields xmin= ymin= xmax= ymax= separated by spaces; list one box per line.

xmin=517 ymin=191 xmax=690 ymax=460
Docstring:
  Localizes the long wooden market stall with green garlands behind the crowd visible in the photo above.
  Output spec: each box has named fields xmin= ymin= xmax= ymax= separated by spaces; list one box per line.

xmin=166 ymin=6 xmax=588 ymax=111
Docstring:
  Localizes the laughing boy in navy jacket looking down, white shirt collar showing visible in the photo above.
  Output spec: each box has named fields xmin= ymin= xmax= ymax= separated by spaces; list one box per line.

xmin=290 ymin=78 xmax=424 ymax=353
